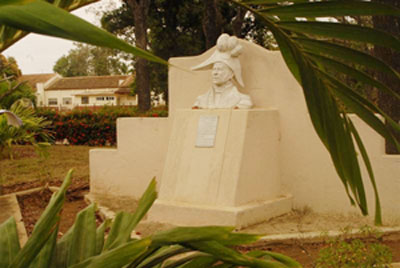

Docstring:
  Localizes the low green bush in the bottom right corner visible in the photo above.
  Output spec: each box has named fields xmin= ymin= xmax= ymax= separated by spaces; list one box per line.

xmin=316 ymin=238 xmax=392 ymax=268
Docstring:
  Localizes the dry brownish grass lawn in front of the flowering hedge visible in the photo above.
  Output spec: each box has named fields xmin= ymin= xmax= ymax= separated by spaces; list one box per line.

xmin=0 ymin=145 xmax=94 ymax=185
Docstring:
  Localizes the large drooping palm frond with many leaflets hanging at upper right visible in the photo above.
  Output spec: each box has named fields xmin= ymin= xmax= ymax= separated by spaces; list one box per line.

xmin=230 ymin=0 xmax=400 ymax=224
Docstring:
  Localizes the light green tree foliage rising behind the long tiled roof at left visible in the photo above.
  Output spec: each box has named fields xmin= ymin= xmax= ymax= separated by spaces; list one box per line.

xmin=53 ymin=43 xmax=128 ymax=77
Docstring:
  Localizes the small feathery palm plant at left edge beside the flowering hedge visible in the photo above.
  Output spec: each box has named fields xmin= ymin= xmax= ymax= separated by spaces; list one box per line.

xmin=0 ymin=102 xmax=52 ymax=159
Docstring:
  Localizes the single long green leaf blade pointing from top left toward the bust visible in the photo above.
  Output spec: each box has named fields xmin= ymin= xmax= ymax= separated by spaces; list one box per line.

xmin=0 ymin=0 xmax=168 ymax=65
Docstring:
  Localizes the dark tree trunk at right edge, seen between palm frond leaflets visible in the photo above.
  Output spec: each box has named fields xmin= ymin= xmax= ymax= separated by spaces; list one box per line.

xmin=373 ymin=0 xmax=400 ymax=154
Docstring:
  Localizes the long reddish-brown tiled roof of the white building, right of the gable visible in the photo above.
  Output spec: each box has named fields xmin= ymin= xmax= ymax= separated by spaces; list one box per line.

xmin=45 ymin=75 xmax=133 ymax=90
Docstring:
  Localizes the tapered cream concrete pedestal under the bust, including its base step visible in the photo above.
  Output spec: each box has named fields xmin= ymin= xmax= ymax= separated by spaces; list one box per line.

xmin=149 ymin=109 xmax=292 ymax=227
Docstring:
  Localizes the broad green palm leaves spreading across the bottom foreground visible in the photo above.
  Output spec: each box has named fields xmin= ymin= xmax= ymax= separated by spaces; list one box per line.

xmin=0 ymin=171 xmax=301 ymax=268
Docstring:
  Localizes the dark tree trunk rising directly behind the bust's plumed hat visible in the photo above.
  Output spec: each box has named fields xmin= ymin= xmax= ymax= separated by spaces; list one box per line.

xmin=203 ymin=0 xmax=222 ymax=49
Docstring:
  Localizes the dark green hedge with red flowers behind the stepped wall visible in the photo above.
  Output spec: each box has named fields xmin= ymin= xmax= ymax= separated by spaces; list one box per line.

xmin=37 ymin=106 xmax=168 ymax=146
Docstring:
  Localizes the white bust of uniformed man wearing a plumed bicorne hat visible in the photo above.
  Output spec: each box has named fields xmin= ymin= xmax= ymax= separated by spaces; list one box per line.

xmin=192 ymin=34 xmax=253 ymax=109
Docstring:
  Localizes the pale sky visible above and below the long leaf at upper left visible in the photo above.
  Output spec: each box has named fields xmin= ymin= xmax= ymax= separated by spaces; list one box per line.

xmin=3 ymin=0 xmax=120 ymax=74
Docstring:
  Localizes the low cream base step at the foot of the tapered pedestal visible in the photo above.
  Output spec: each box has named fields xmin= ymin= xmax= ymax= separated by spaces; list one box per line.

xmin=148 ymin=195 xmax=293 ymax=229
